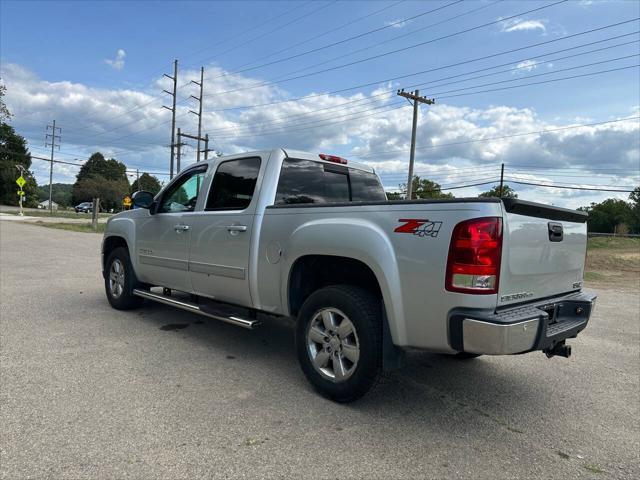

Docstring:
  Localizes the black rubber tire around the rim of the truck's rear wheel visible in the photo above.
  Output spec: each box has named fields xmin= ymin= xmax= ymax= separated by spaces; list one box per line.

xmin=296 ymin=285 xmax=383 ymax=403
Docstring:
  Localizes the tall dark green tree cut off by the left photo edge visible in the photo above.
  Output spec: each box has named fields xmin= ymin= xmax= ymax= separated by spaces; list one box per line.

xmin=0 ymin=122 xmax=38 ymax=207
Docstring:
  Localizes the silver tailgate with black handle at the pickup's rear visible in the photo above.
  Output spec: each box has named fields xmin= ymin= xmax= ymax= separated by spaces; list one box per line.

xmin=498 ymin=199 xmax=587 ymax=306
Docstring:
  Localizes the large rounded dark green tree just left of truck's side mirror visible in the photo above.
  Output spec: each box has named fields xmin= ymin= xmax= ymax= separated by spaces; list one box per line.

xmin=72 ymin=152 xmax=131 ymax=210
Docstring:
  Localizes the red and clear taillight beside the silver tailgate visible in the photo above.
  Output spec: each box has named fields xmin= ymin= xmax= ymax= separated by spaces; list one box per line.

xmin=445 ymin=217 xmax=502 ymax=294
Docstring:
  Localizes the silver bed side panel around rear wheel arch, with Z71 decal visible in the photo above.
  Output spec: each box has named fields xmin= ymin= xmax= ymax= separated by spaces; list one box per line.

xmin=256 ymin=201 xmax=502 ymax=352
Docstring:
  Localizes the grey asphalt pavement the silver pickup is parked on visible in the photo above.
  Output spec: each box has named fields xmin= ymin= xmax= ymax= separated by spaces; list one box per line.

xmin=0 ymin=222 xmax=640 ymax=479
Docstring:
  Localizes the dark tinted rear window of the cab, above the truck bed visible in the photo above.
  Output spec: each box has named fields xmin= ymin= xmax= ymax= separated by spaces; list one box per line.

xmin=275 ymin=158 xmax=387 ymax=205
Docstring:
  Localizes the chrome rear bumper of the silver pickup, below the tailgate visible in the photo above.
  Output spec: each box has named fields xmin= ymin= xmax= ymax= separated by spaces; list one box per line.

xmin=449 ymin=292 xmax=597 ymax=355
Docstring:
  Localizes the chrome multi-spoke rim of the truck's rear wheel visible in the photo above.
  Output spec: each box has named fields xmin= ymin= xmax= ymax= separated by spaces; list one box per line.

xmin=307 ymin=308 xmax=360 ymax=382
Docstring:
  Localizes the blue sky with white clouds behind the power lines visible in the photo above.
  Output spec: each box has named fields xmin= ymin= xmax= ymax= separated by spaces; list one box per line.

xmin=0 ymin=0 xmax=640 ymax=206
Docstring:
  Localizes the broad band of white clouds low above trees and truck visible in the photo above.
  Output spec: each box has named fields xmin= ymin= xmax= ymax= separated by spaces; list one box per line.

xmin=0 ymin=63 xmax=640 ymax=207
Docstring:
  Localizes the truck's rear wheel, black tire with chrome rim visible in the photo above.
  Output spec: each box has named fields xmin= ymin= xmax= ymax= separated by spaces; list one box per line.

xmin=296 ymin=285 xmax=383 ymax=402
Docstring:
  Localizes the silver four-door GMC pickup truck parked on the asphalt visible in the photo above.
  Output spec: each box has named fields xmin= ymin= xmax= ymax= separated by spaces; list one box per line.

xmin=102 ymin=149 xmax=596 ymax=402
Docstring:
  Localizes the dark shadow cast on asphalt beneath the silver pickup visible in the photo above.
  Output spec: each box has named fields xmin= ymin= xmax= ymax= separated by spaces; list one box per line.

xmin=131 ymin=302 xmax=553 ymax=435
